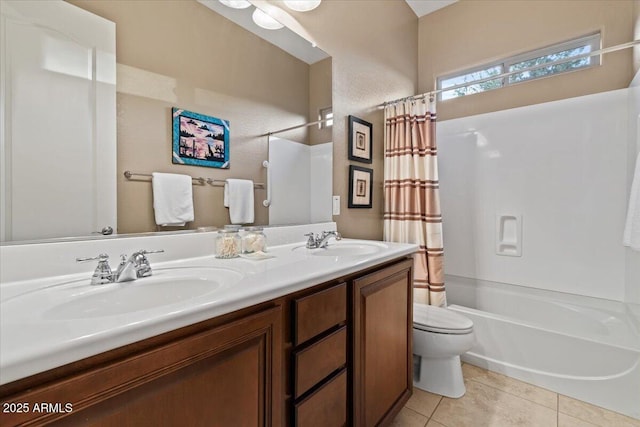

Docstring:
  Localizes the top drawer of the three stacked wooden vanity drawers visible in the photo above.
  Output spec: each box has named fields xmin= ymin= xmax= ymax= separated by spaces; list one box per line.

xmin=293 ymin=283 xmax=347 ymax=345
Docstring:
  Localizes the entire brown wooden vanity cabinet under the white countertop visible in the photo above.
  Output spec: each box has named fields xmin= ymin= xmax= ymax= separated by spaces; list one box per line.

xmin=0 ymin=258 xmax=413 ymax=427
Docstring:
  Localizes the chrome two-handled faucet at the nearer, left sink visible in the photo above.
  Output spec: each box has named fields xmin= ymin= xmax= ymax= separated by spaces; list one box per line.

xmin=76 ymin=249 xmax=164 ymax=285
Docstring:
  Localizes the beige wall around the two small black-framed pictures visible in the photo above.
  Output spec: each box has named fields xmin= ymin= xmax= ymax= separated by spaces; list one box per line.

xmin=290 ymin=0 xmax=418 ymax=239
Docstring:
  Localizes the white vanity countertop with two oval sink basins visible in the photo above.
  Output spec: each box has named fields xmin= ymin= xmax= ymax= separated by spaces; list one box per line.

xmin=0 ymin=237 xmax=416 ymax=384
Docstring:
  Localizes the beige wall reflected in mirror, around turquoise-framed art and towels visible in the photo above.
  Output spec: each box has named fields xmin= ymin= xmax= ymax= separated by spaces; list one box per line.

xmin=70 ymin=0 xmax=309 ymax=233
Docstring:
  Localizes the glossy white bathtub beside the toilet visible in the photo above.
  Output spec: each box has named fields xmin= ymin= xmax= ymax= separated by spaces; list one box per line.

xmin=445 ymin=276 xmax=640 ymax=419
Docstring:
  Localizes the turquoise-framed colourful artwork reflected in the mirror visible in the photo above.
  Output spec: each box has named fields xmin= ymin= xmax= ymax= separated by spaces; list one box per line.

xmin=171 ymin=107 xmax=229 ymax=169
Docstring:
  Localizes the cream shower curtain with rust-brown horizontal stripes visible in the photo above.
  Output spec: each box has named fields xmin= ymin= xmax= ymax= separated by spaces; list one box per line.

xmin=384 ymin=99 xmax=447 ymax=307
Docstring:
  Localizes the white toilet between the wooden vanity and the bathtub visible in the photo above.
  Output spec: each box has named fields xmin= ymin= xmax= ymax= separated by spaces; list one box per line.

xmin=413 ymin=304 xmax=476 ymax=398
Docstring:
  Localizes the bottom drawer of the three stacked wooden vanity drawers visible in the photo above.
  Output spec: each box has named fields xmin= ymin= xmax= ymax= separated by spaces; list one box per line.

xmin=294 ymin=369 xmax=347 ymax=427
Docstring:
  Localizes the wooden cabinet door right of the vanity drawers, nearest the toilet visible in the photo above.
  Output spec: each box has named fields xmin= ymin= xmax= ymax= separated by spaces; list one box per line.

xmin=353 ymin=260 xmax=413 ymax=427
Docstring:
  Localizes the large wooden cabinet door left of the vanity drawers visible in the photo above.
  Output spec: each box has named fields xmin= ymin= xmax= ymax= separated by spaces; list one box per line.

xmin=1 ymin=306 xmax=282 ymax=427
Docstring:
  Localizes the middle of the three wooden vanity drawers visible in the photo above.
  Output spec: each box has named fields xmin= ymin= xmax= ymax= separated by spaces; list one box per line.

xmin=294 ymin=326 xmax=347 ymax=398
